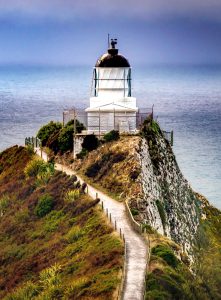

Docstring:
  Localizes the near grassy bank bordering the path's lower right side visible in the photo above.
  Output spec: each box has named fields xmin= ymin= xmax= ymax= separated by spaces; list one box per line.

xmin=145 ymin=234 xmax=204 ymax=300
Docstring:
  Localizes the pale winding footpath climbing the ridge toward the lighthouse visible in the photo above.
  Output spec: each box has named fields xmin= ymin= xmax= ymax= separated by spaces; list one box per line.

xmin=36 ymin=148 xmax=148 ymax=300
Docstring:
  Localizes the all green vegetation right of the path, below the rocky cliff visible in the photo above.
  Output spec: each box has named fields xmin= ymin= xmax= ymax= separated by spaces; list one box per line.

xmin=145 ymin=214 xmax=221 ymax=300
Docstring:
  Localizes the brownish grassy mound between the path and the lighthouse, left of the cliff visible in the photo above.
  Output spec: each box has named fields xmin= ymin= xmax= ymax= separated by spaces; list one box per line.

xmin=76 ymin=136 xmax=140 ymax=200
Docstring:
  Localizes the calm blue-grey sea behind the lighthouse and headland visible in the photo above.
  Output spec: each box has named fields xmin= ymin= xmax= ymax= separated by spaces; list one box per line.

xmin=0 ymin=66 xmax=221 ymax=208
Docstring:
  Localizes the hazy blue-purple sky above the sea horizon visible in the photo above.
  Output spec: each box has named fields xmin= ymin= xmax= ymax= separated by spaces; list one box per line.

xmin=0 ymin=0 xmax=221 ymax=66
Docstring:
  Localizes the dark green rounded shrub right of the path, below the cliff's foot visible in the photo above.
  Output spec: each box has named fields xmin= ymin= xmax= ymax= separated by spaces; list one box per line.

xmin=151 ymin=245 xmax=179 ymax=268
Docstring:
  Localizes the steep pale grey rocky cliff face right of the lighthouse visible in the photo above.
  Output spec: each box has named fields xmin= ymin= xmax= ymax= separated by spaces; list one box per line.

xmin=136 ymin=129 xmax=201 ymax=254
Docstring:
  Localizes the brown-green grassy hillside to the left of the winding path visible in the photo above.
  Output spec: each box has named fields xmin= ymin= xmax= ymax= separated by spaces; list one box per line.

xmin=0 ymin=146 xmax=123 ymax=300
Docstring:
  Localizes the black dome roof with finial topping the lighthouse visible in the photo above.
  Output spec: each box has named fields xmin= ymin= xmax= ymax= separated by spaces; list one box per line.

xmin=95 ymin=40 xmax=130 ymax=68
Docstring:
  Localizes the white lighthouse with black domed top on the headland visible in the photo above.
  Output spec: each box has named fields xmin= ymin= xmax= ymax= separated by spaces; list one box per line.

xmin=85 ymin=39 xmax=138 ymax=134
